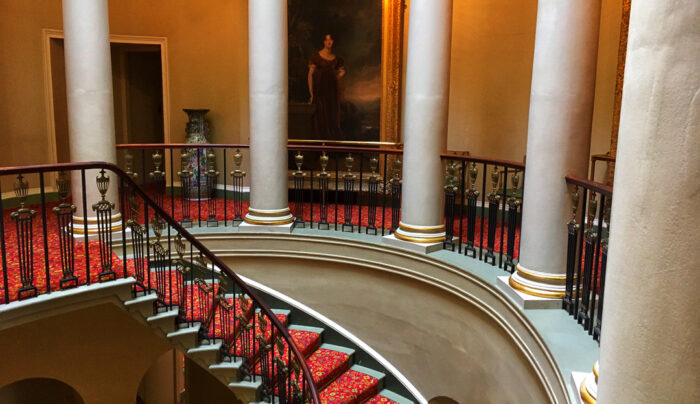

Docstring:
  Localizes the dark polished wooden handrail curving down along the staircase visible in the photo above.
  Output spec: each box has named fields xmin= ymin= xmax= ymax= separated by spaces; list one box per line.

xmin=0 ymin=161 xmax=320 ymax=404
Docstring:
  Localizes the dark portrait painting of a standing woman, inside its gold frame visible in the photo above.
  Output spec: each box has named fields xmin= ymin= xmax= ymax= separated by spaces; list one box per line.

xmin=288 ymin=0 xmax=382 ymax=141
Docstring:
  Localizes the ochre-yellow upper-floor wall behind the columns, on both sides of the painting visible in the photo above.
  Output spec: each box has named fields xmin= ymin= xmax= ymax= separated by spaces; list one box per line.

xmin=0 ymin=0 xmax=621 ymax=171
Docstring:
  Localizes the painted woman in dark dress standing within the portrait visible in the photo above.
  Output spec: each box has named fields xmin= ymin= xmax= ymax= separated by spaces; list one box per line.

xmin=308 ymin=34 xmax=345 ymax=140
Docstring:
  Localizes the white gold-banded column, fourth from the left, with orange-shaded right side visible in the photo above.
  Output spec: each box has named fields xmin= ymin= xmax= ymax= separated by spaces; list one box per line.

xmin=509 ymin=0 xmax=600 ymax=300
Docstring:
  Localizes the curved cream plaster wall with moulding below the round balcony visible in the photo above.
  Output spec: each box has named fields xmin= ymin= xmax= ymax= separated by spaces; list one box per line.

xmin=198 ymin=234 xmax=568 ymax=403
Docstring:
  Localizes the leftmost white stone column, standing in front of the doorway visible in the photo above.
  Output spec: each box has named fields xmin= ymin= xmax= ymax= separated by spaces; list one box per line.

xmin=63 ymin=0 xmax=121 ymax=224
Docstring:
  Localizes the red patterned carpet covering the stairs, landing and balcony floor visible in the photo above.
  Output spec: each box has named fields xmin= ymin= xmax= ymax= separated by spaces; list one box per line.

xmin=0 ymin=197 xmax=519 ymax=404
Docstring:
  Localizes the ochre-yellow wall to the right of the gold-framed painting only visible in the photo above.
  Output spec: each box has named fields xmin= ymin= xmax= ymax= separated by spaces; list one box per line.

xmin=447 ymin=0 xmax=621 ymax=167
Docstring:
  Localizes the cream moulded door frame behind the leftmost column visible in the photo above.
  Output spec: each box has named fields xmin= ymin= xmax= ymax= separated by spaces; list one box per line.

xmin=42 ymin=28 xmax=170 ymax=163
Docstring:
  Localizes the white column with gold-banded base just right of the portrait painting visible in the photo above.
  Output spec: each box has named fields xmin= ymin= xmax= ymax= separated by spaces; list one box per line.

xmin=385 ymin=0 xmax=452 ymax=251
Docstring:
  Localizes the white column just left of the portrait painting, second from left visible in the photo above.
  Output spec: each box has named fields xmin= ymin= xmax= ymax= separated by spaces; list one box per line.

xmin=240 ymin=0 xmax=294 ymax=231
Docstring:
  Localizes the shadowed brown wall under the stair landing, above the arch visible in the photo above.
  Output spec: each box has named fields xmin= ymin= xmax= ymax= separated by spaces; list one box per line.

xmin=0 ymin=303 xmax=171 ymax=404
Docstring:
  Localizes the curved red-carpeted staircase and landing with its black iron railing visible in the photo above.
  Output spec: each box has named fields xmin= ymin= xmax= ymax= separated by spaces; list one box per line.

xmin=0 ymin=163 xmax=413 ymax=404
